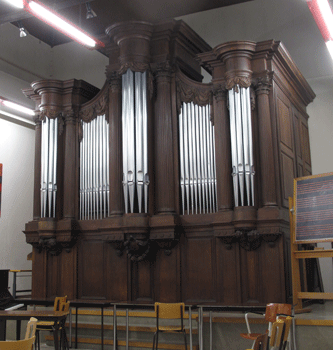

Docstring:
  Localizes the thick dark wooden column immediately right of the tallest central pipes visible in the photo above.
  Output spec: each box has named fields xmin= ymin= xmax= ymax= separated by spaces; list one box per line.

xmin=154 ymin=62 xmax=175 ymax=214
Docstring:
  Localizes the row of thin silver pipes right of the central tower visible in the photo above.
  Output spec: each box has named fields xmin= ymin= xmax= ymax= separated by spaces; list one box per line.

xmin=179 ymin=102 xmax=217 ymax=214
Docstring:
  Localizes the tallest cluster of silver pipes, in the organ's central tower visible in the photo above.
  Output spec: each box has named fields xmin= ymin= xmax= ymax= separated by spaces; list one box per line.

xmin=122 ymin=69 xmax=149 ymax=213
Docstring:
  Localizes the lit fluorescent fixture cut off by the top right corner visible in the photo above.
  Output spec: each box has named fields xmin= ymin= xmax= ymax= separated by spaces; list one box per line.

xmin=307 ymin=0 xmax=333 ymax=59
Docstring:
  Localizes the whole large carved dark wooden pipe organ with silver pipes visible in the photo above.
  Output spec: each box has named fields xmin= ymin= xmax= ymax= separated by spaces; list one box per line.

xmin=25 ymin=20 xmax=314 ymax=305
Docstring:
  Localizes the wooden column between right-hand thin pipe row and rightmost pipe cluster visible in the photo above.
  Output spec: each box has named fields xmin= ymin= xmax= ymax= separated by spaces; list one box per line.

xmin=214 ymin=88 xmax=233 ymax=211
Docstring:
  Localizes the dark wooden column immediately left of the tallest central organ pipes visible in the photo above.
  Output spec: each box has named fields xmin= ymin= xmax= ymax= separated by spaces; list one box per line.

xmin=109 ymin=72 xmax=124 ymax=216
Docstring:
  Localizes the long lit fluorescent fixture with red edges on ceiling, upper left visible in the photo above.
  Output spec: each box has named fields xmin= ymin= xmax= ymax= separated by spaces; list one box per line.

xmin=24 ymin=0 xmax=105 ymax=48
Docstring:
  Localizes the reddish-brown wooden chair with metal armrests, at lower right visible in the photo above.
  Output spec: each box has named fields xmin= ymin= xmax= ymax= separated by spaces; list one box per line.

xmin=240 ymin=303 xmax=291 ymax=349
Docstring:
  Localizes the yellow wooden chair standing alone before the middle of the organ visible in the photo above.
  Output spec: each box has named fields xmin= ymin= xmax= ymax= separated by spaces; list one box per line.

xmin=153 ymin=303 xmax=187 ymax=350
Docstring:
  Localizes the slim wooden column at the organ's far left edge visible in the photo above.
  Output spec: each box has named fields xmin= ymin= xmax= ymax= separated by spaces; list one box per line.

xmin=33 ymin=116 xmax=42 ymax=220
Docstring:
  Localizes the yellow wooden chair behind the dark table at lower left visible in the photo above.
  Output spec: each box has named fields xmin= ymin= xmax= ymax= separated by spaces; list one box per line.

xmin=35 ymin=296 xmax=70 ymax=350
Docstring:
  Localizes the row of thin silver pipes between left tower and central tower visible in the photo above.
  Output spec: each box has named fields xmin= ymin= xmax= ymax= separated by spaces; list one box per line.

xmin=80 ymin=115 xmax=109 ymax=220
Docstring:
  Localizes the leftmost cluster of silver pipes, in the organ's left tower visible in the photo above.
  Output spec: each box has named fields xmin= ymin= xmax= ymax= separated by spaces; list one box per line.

xmin=41 ymin=117 xmax=58 ymax=218
